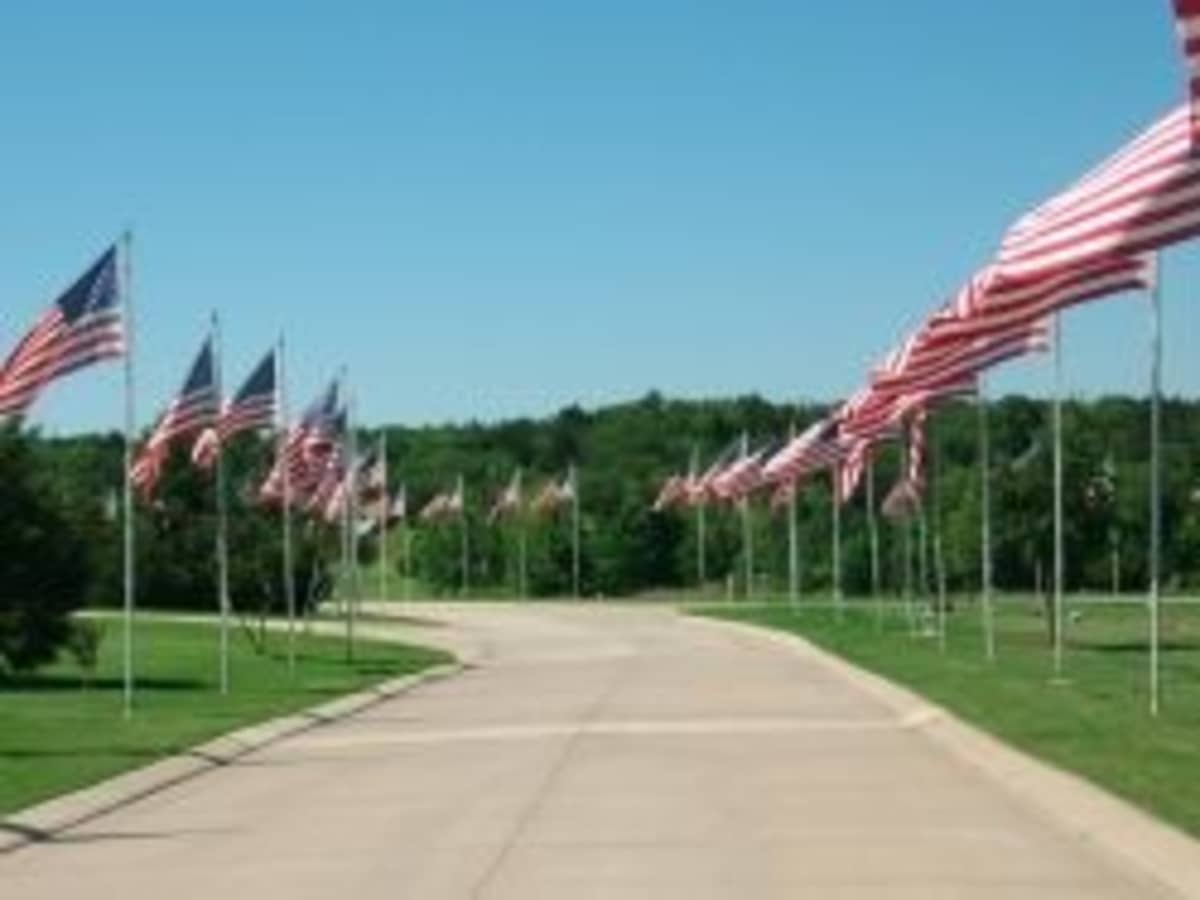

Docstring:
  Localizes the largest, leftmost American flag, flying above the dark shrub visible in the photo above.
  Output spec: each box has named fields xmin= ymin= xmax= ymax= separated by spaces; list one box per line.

xmin=0 ymin=247 xmax=125 ymax=416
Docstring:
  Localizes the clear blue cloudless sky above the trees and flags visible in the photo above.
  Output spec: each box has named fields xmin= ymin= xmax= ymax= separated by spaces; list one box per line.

xmin=0 ymin=0 xmax=1200 ymax=431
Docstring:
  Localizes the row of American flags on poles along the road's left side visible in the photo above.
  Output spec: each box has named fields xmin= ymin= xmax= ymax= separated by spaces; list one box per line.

xmin=0 ymin=234 xmax=580 ymax=714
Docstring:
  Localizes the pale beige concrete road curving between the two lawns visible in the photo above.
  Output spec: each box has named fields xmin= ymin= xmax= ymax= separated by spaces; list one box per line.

xmin=0 ymin=607 xmax=1180 ymax=900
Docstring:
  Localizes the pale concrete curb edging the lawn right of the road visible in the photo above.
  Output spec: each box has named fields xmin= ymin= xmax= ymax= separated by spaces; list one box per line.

xmin=689 ymin=617 xmax=1200 ymax=898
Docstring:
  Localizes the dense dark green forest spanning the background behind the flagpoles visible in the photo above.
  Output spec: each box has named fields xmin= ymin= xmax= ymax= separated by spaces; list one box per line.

xmin=0 ymin=394 xmax=1200 ymax=638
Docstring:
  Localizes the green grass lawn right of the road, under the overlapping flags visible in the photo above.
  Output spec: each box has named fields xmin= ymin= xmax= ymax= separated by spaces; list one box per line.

xmin=701 ymin=598 xmax=1200 ymax=835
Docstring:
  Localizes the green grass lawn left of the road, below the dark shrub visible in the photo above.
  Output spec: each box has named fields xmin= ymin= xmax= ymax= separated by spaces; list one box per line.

xmin=0 ymin=619 xmax=450 ymax=814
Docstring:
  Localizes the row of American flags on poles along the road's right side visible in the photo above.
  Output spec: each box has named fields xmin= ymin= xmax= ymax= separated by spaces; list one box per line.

xmin=656 ymin=0 xmax=1200 ymax=714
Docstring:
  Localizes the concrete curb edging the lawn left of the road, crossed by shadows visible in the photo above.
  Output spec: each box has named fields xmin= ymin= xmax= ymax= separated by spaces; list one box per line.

xmin=0 ymin=664 xmax=466 ymax=854
